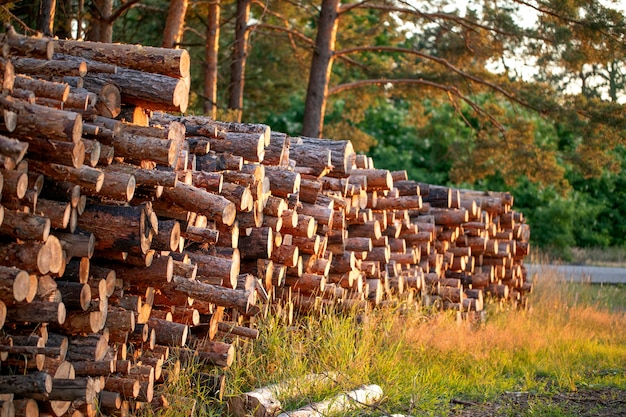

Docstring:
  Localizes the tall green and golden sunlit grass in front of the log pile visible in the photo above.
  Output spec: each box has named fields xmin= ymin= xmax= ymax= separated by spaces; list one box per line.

xmin=150 ymin=264 xmax=626 ymax=416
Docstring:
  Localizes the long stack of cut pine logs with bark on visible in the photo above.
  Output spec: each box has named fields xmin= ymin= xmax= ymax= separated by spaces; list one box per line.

xmin=0 ymin=27 xmax=532 ymax=416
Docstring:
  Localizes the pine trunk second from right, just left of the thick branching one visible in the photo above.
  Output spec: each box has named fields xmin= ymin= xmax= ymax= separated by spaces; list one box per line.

xmin=228 ymin=0 xmax=250 ymax=122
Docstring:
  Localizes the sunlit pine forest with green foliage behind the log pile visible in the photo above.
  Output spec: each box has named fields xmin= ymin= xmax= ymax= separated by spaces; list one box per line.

xmin=8 ymin=0 xmax=626 ymax=260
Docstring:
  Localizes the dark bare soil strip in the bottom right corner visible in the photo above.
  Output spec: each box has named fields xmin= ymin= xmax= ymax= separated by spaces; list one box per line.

xmin=450 ymin=388 xmax=626 ymax=417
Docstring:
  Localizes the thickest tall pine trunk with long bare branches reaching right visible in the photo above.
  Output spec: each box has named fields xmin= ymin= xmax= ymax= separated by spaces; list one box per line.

xmin=302 ymin=0 xmax=339 ymax=138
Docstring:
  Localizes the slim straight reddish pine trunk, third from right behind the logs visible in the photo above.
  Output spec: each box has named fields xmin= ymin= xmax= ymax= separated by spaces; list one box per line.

xmin=204 ymin=0 xmax=220 ymax=120
